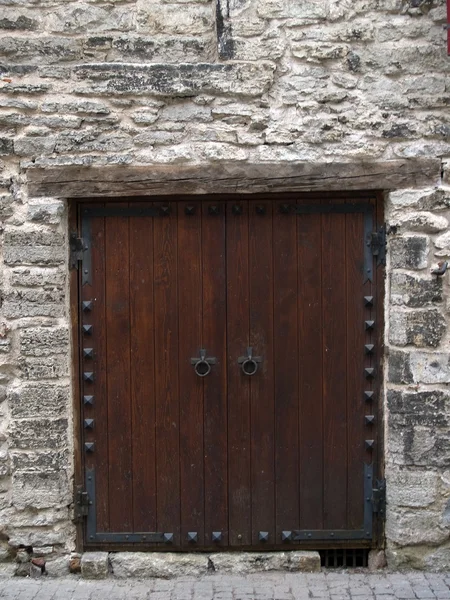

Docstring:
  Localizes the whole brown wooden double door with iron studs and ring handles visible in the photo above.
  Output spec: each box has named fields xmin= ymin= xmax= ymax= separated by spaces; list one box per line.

xmin=79 ymin=195 xmax=377 ymax=550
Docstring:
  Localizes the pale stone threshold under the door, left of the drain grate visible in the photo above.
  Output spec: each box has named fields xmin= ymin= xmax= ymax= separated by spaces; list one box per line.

xmin=81 ymin=551 xmax=320 ymax=579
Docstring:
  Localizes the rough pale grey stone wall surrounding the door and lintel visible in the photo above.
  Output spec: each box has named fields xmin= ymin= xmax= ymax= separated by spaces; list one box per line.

xmin=0 ymin=0 xmax=450 ymax=568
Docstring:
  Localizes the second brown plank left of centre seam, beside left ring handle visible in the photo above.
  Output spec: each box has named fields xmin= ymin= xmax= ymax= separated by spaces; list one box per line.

xmin=178 ymin=202 xmax=204 ymax=547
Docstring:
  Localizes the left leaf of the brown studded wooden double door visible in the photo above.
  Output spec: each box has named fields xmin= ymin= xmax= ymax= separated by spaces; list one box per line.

xmin=80 ymin=202 xmax=227 ymax=549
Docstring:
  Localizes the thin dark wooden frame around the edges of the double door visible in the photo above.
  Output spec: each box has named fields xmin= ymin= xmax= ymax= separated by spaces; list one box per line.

xmin=68 ymin=190 xmax=386 ymax=552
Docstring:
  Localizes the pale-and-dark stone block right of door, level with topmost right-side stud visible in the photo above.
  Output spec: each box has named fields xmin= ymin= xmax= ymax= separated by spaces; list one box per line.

xmin=390 ymin=271 xmax=443 ymax=308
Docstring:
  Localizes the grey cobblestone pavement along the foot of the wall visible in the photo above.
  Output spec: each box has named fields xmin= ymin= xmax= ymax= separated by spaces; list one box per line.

xmin=0 ymin=571 xmax=450 ymax=600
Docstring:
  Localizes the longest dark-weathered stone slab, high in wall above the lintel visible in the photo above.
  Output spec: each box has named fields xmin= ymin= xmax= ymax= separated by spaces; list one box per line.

xmin=74 ymin=62 xmax=274 ymax=97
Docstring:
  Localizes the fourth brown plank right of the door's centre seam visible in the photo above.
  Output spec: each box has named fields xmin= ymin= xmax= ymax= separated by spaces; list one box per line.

xmin=297 ymin=214 xmax=324 ymax=529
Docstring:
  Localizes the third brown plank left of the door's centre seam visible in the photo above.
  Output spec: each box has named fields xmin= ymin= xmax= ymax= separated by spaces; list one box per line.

xmin=153 ymin=203 xmax=180 ymax=545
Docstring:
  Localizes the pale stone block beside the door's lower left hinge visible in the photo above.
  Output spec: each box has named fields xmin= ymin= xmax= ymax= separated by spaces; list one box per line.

xmin=12 ymin=471 xmax=72 ymax=510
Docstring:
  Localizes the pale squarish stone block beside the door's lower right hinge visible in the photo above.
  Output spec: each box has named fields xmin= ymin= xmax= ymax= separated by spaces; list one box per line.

xmin=386 ymin=469 xmax=438 ymax=509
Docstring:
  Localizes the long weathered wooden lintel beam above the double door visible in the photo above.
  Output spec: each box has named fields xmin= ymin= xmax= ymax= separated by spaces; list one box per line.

xmin=27 ymin=159 xmax=441 ymax=198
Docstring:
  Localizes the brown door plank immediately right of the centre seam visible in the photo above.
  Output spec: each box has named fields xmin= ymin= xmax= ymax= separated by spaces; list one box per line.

xmin=226 ymin=200 xmax=252 ymax=546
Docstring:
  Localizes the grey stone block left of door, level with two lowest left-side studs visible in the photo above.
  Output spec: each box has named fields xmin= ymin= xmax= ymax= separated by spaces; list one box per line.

xmin=8 ymin=418 xmax=69 ymax=451
